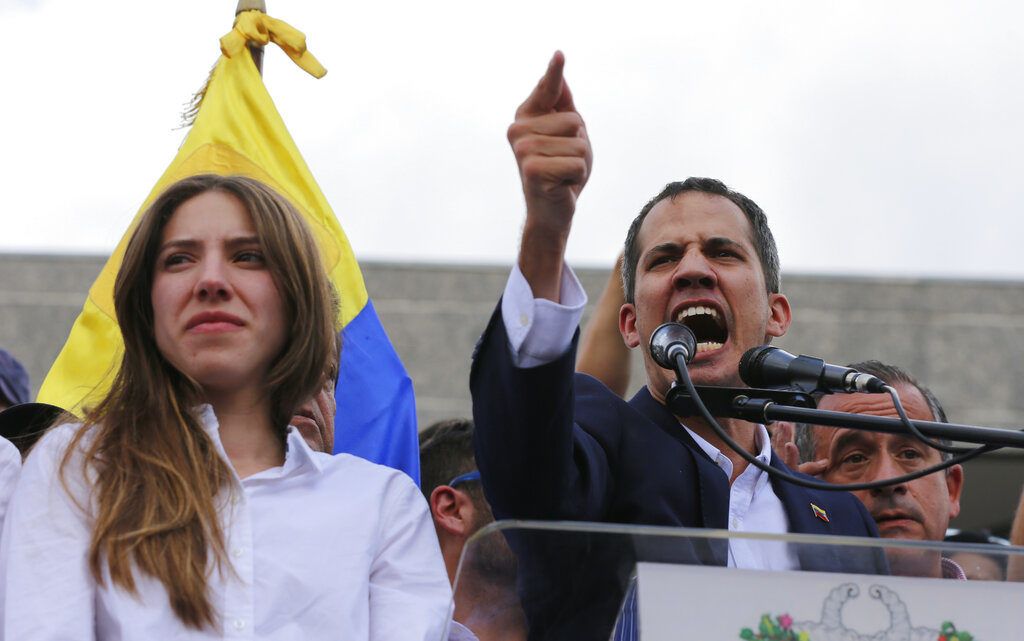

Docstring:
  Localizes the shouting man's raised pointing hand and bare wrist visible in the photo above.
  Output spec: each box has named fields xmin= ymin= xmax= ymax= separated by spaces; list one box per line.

xmin=508 ymin=51 xmax=593 ymax=302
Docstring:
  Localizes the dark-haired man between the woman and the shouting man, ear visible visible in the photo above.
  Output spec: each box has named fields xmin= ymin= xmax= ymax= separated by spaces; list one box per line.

xmin=420 ymin=419 xmax=526 ymax=641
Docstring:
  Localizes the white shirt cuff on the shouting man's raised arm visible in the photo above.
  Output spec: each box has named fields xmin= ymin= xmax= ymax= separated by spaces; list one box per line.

xmin=502 ymin=264 xmax=587 ymax=368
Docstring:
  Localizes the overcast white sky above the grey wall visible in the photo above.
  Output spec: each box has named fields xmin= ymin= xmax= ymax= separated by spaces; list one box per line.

xmin=0 ymin=0 xmax=1024 ymax=279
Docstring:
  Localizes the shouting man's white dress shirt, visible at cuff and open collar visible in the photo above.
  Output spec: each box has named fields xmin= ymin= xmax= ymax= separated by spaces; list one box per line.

xmin=502 ymin=264 xmax=799 ymax=569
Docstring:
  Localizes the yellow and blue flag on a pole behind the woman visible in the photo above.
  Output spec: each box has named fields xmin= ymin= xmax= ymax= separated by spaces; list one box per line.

xmin=39 ymin=11 xmax=420 ymax=481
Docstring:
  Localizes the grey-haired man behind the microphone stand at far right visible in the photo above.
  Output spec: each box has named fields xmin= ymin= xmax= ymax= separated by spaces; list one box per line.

xmin=796 ymin=360 xmax=966 ymax=579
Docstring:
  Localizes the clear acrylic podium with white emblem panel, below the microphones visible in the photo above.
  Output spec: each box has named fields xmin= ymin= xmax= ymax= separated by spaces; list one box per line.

xmin=451 ymin=521 xmax=1024 ymax=641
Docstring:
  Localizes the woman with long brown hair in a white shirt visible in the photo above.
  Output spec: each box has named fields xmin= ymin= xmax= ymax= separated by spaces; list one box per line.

xmin=0 ymin=175 xmax=450 ymax=641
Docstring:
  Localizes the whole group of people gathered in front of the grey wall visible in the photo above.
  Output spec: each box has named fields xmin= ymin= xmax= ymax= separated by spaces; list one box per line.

xmin=0 ymin=53 xmax=1024 ymax=641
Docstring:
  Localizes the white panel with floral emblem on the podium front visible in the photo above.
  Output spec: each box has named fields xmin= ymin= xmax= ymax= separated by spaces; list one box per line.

xmin=637 ymin=562 xmax=1024 ymax=641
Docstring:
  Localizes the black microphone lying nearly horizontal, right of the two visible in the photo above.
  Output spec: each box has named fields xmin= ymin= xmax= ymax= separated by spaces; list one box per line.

xmin=739 ymin=345 xmax=886 ymax=394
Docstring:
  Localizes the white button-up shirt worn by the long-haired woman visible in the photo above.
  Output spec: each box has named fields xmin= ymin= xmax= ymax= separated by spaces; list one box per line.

xmin=0 ymin=405 xmax=452 ymax=641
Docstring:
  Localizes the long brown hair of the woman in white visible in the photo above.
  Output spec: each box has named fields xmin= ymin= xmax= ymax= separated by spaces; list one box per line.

xmin=61 ymin=175 xmax=337 ymax=629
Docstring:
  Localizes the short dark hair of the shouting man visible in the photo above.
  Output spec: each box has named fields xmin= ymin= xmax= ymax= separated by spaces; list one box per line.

xmin=623 ymin=177 xmax=781 ymax=303
